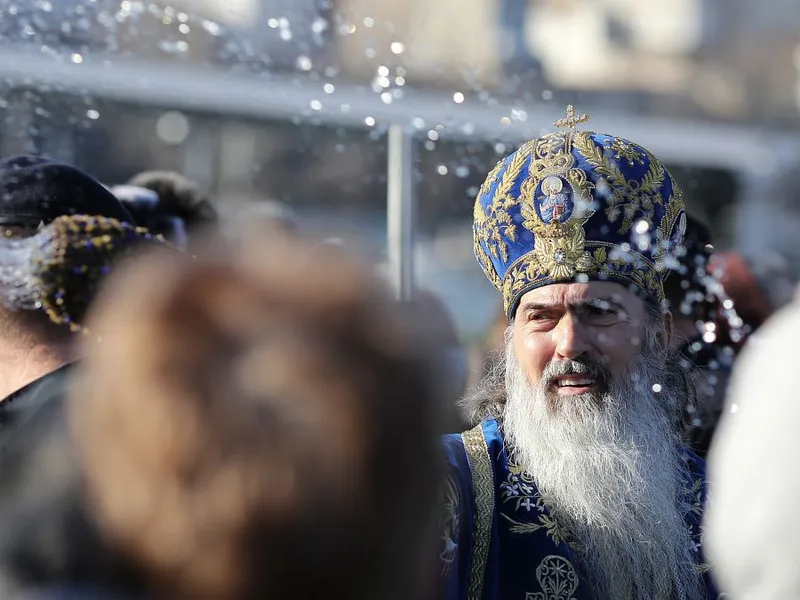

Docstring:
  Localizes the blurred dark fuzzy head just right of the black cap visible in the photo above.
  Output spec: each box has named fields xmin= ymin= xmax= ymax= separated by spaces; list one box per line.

xmin=122 ymin=171 xmax=219 ymax=241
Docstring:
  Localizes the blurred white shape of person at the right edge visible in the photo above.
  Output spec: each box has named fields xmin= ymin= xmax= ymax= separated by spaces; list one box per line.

xmin=706 ymin=304 xmax=800 ymax=600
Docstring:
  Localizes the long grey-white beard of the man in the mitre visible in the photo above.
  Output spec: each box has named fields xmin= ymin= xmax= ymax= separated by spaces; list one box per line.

xmin=503 ymin=330 xmax=704 ymax=600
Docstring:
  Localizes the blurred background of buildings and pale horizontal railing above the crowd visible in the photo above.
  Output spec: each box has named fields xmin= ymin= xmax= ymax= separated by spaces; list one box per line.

xmin=0 ymin=0 xmax=800 ymax=337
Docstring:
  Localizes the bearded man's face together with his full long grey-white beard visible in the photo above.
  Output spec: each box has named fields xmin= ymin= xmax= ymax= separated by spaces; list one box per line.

xmin=502 ymin=282 xmax=699 ymax=598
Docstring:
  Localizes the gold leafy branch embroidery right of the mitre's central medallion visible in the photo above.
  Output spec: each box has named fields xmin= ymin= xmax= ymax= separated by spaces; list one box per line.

xmin=572 ymin=131 xmax=666 ymax=235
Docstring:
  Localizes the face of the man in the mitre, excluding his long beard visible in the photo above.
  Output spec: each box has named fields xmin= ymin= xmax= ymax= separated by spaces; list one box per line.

xmin=513 ymin=281 xmax=664 ymax=398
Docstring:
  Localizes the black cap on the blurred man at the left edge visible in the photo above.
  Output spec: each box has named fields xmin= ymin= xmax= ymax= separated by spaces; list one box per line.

xmin=0 ymin=156 xmax=136 ymax=227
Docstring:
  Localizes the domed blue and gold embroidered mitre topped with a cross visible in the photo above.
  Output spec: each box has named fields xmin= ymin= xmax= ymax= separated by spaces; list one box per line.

xmin=473 ymin=106 xmax=686 ymax=320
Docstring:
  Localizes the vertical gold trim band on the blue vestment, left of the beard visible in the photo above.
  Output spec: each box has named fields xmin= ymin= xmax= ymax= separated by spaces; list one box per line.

xmin=461 ymin=425 xmax=494 ymax=600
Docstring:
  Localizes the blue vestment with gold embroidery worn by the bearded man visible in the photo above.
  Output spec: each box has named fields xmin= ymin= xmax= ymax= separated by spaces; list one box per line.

xmin=441 ymin=420 xmax=717 ymax=600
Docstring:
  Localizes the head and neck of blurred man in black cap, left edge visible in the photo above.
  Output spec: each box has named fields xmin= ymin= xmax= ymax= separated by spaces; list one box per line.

xmin=0 ymin=156 xmax=139 ymax=437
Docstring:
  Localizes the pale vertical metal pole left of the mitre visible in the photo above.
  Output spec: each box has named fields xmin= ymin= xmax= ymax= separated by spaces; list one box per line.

xmin=386 ymin=125 xmax=415 ymax=300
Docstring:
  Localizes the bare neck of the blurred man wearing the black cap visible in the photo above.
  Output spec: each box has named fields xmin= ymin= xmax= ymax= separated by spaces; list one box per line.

xmin=0 ymin=342 xmax=73 ymax=400
